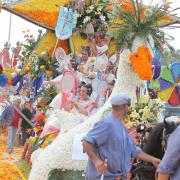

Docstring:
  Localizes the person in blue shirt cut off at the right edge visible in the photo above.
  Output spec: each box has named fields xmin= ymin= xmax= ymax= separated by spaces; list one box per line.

xmin=158 ymin=126 xmax=180 ymax=180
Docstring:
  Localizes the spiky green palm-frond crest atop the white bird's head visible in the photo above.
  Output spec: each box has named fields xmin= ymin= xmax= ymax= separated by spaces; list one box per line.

xmin=107 ymin=0 xmax=180 ymax=49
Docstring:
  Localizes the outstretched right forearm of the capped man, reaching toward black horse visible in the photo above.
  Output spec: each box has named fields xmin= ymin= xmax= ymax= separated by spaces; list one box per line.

xmin=135 ymin=152 xmax=160 ymax=167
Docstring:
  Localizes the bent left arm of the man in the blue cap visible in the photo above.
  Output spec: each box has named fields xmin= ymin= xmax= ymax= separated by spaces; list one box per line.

xmin=83 ymin=140 xmax=108 ymax=175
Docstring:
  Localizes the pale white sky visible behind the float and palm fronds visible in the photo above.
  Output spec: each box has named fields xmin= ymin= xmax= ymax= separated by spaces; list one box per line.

xmin=0 ymin=0 xmax=180 ymax=50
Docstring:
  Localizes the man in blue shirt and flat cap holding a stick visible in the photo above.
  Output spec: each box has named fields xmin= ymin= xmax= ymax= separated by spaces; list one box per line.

xmin=83 ymin=94 xmax=160 ymax=180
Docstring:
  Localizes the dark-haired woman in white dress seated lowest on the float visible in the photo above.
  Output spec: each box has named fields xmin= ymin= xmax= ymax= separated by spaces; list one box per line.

xmin=43 ymin=83 xmax=96 ymax=133
